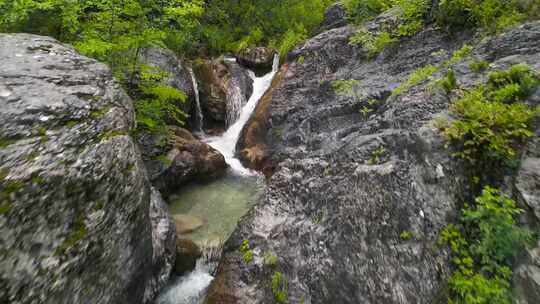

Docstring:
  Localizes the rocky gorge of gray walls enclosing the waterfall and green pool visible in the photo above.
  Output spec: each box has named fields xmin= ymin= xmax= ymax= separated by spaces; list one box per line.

xmin=0 ymin=5 xmax=540 ymax=304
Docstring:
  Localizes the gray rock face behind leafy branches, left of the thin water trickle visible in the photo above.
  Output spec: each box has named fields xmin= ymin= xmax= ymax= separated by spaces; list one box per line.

xmin=140 ymin=48 xmax=195 ymax=124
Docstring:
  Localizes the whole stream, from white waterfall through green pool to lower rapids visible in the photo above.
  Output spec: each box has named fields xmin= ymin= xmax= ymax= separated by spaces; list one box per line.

xmin=157 ymin=55 xmax=279 ymax=304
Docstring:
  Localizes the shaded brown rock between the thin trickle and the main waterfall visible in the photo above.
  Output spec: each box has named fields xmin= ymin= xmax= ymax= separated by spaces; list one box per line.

xmin=195 ymin=59 xmax=253 ymax=130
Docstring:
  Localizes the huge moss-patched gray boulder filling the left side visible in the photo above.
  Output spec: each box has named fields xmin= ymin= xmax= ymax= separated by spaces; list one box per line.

xmin=0 ymin=34 xmax=174 ymax=304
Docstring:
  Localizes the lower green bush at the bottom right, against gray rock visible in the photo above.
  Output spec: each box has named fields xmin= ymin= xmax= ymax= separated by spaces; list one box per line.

xmin=440 ymin=187 xmax=534 ymax=304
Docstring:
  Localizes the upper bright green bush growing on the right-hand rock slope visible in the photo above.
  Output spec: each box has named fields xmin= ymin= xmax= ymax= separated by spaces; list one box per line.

xmin=444 ymin=65 xmax=539 ymax=163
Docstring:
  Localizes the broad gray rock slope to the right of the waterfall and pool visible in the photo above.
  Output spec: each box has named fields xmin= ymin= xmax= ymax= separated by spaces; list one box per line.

xmin=207 ymin=17 xmax=540 ymax=304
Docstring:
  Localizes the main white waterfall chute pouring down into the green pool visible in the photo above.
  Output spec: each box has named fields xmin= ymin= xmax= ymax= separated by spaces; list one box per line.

xmin=206 ymin=55 xmax=279 ymax=175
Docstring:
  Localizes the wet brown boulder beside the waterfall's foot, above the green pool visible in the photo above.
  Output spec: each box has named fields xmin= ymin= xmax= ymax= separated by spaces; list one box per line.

xmin=137 ymin=126 xmax=227 ymax=196
